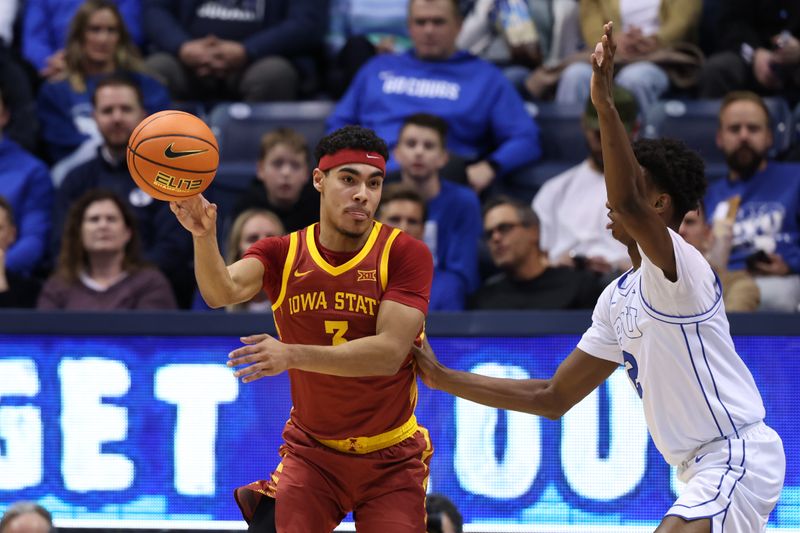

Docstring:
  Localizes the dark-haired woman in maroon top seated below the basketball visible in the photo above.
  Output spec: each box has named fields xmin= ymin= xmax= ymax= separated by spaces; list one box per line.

xmin=37 ymin=189 xmax=176 ymax=310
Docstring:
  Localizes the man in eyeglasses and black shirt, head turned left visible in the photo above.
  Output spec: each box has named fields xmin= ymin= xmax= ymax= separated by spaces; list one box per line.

xmin=469 ymin=196 xmax=603 ymax=309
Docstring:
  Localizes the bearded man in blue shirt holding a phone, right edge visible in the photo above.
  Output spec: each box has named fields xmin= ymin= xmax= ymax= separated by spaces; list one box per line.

xmin=705 ymin=91 xmax=800 ymax=311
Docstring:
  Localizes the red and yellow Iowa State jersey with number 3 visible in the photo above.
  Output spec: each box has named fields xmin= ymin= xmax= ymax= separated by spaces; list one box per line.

xmin=245 ymin=222 xmax=433 ymax=442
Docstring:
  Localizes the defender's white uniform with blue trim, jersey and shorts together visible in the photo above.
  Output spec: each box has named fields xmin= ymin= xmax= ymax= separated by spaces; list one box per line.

xmin=578 ymin=230 xmax=786 ymax=533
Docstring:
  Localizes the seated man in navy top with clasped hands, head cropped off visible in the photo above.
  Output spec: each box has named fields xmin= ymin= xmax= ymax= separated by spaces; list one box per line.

xmin=144 ymin=0 xmax=328 ymax=102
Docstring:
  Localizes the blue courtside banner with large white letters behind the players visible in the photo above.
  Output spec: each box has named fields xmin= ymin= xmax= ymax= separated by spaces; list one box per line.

xmin=0 ymin=334 xmax=800 ymax=531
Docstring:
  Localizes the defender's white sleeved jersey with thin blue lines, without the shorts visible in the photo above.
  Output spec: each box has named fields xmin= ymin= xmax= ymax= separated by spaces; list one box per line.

xmin=578 ymin=230 xmax=764 ymax=465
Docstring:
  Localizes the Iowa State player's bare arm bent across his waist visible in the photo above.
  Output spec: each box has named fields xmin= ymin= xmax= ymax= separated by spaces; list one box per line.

xmin=228 ymin=300 xmax=425 ymax=383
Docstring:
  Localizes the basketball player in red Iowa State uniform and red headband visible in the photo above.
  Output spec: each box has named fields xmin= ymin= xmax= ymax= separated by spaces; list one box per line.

xmin=171 ymin=126 xmax=433 ymax=533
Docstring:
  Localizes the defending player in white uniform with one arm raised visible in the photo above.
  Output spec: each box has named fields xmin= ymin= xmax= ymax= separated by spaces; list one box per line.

xmin=415 ymin=23 xmax=786 ymax=533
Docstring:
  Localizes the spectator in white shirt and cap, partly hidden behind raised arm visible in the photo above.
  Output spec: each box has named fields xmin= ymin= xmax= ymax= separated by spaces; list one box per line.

xmin=532 ymin=86 xmax=639 ymax=275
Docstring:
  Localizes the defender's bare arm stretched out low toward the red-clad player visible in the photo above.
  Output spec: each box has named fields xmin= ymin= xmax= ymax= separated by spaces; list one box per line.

xmin=412 ymin=341 xmax=619 ymax=419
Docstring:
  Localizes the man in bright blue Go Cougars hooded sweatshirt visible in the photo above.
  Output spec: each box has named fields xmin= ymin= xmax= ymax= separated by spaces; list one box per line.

xmin=328 ymin=0 xmax=541 ymax=192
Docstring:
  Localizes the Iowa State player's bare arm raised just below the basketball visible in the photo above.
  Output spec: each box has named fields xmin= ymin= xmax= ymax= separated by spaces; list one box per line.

xmin=170 ymin=194 xmax=264 ymax=308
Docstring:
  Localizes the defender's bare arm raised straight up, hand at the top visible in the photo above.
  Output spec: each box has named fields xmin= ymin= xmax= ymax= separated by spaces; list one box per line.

xmin=591 ymin=22 xmax=677 ymax=281
